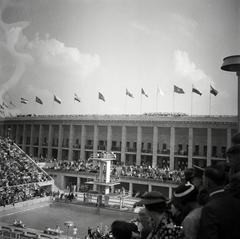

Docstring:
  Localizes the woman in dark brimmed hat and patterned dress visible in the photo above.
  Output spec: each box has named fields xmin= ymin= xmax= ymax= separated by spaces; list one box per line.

xmin=135 ymin=191 xmax=183 ymax=239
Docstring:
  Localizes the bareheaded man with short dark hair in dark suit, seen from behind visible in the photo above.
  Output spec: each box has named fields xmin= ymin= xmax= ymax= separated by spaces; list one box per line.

xmin=200 ymin=166 xmax=240 ymax=239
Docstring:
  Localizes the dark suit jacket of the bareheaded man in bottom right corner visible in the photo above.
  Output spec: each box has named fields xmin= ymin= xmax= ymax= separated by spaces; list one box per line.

xmin=200 ymin=192 xmax=240 ymax=239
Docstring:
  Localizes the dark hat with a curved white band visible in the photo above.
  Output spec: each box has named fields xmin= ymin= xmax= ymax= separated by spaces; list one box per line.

xmin=173 ymin=183 xmax=198 ymax=204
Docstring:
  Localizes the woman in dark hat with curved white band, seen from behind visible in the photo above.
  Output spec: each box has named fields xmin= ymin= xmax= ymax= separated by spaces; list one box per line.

xmin=173 ymin=183 xmax=202 ymax=239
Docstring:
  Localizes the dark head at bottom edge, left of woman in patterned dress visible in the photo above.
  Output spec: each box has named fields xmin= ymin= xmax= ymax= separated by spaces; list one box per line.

xmin=111 ymin=220 xmax=132 ymax=239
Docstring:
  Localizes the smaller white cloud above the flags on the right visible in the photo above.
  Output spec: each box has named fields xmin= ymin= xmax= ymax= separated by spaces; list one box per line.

xmin=173 ymin=50 xmax=209 ymax=82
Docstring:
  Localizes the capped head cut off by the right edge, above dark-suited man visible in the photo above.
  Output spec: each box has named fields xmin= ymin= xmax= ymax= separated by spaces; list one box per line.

xmin=227 ymin=144 xmax=240 ymax=173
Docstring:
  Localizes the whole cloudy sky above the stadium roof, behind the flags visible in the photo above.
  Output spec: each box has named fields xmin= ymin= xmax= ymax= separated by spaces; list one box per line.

xmin=0 ymin=0 xmax=240 ymax=116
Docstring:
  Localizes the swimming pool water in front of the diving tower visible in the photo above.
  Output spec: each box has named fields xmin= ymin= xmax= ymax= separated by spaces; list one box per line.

xmin=0 ymin=203 xmax=136 ymax=238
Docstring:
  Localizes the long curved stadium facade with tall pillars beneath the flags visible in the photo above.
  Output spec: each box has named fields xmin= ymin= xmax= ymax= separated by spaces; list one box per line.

xmin=0 ymin=113 xmax=238 ymax=170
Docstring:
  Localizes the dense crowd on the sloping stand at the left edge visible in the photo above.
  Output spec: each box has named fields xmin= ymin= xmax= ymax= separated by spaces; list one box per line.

xmin=0 ymin=138 xmax=51 ymax=206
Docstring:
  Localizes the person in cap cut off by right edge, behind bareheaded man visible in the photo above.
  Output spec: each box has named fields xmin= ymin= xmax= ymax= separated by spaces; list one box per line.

xmin=225 ymin=144 xmax=240 ymax=199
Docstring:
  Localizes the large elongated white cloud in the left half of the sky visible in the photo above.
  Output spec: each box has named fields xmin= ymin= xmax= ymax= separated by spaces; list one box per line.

xmin=18 ymin=34 xmax=100 ymax=76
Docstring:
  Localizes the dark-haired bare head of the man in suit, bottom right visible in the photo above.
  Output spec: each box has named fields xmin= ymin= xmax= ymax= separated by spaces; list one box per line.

xmin=203 ymin=165 xmax=226 ymax=193
